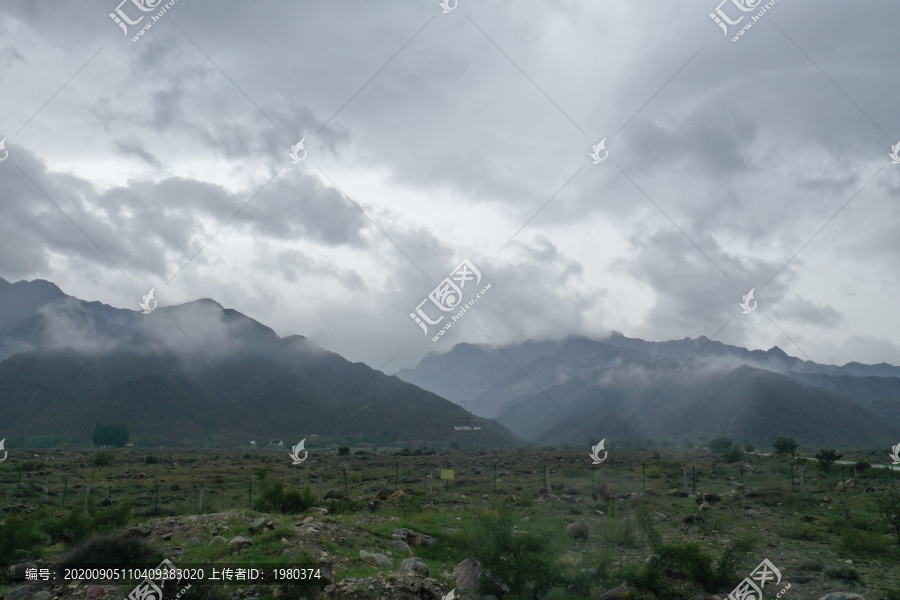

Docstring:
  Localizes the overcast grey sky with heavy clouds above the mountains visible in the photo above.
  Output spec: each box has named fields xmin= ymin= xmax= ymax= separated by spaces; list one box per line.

xmin=0 ymin=0 xmax=900 ymax=372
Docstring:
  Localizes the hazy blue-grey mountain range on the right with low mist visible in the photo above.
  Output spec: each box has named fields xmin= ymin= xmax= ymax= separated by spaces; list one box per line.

xmin=397 ymin=333 xmax=900 ymax=448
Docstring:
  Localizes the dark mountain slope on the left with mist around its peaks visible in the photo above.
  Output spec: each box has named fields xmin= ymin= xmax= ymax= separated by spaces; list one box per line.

xmin=0 ymin=279 xmax=517 ymax=445
